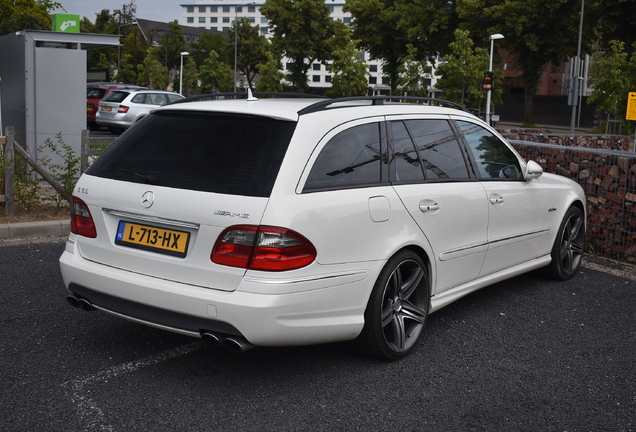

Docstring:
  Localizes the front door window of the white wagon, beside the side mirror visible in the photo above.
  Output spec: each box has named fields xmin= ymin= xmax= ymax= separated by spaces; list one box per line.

xmin=457 ymin=121 xmax=523 ymax=179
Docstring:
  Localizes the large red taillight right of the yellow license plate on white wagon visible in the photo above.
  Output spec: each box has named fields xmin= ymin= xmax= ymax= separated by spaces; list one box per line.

xmin=210 ymin=225 xmax=316 ymax=271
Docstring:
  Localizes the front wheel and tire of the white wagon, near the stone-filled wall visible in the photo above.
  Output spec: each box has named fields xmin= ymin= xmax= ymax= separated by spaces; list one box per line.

xmin=546 ymin=206 xmax=585 ymax=281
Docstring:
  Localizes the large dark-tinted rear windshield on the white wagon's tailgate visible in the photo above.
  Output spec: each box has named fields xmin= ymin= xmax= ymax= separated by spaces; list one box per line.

xmin=87 ymin=111 xmax=296 ymax=197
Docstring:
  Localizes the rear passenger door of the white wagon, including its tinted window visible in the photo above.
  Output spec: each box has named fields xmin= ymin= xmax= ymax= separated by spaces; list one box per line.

xmin=388 ymin=117 xmax=488 ymax=294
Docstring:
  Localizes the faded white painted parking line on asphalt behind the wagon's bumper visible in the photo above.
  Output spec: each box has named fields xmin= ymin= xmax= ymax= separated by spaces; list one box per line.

xmin=62 ymin=341 xmax=204 ymax=432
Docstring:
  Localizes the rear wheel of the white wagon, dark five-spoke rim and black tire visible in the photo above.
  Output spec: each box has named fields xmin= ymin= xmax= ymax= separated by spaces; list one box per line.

xmin=354 ymin=250 xmax=430 ymax=360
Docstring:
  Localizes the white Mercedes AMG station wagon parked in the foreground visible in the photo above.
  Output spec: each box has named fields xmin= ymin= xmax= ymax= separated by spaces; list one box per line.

xmin=60 ymin=93 xmax=585 ymax=360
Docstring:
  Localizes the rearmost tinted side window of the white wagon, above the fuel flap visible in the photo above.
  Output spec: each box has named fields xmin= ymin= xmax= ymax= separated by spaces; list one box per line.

xmin=305 ymin=123 xmax=382 ymax=190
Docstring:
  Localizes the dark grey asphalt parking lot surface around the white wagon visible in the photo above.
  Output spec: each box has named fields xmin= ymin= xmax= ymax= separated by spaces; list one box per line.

xmin=0 ymin=239 xmax=636 ymax=432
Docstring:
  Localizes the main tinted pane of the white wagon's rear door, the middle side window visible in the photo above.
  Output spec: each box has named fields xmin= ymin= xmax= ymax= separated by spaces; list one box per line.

xmin=406 ymin=120 xmax=469 ymax=180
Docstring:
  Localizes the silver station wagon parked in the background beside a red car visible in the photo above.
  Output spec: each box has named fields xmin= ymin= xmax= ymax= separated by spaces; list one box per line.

xmin=95 ymin=89 xmax=183 ymax=134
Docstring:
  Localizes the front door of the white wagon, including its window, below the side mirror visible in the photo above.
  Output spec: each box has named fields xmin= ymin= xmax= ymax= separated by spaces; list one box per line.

xmin=457 ymin=120 xmax=548 ymax=276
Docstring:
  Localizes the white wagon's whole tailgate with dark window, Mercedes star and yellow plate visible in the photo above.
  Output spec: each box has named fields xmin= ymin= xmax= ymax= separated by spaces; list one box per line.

xmin=75 ymin=110 xmax=296 ymax=291
